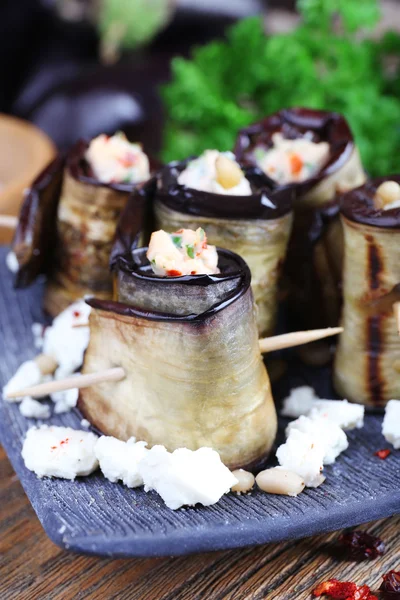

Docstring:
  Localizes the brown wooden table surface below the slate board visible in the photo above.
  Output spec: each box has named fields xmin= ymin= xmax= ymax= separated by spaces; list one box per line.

xmin=0 ymin=447 xmax=400 ymax=600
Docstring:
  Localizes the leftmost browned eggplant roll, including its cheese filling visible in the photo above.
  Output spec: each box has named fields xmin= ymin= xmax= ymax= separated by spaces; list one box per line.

xmin=13 ymin=134 xmax=150 ymax=315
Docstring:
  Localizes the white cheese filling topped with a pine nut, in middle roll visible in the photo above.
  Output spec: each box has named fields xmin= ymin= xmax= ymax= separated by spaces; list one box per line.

xmin=178 ymin=150 xmax=252 ymax=196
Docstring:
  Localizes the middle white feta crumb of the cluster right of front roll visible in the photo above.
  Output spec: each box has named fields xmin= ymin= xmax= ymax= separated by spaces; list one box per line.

xmin=286 ymin=416 xmax=349 ymax=465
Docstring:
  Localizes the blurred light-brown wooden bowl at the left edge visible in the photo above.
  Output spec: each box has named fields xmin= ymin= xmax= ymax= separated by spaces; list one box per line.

xmin=0 ymin=114 xmax=56 ymax=244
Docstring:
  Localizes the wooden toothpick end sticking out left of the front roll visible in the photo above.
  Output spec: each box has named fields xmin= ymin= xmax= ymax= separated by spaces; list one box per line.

xmin=7 ymin=367 xmax=125 ymax=398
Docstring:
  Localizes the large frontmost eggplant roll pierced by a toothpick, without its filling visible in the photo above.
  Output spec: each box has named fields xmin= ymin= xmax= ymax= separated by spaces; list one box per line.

xmin=79 ymin=248 xmax=277 ymax=468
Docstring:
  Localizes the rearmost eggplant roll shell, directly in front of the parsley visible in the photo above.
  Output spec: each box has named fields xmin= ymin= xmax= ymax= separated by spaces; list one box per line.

xmin=235 ymin=108 xmax=365 ymax=329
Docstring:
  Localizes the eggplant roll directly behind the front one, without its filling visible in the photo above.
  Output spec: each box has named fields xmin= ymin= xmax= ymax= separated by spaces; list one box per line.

xmin=154 ymin=160 xmax=293 ymax=336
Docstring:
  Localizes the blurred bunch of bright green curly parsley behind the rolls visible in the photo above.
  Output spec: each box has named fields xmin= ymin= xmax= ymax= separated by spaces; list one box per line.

xmin=162 ymin=0 xmax=400 ymax=175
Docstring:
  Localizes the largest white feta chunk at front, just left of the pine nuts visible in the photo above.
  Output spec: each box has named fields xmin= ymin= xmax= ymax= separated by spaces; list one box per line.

xmin=138 ymin=446 xmax=238 ymax=510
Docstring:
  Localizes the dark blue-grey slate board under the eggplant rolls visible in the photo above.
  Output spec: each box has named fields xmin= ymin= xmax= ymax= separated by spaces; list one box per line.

xmin=0 ymin=248 xmax=400 ymax=556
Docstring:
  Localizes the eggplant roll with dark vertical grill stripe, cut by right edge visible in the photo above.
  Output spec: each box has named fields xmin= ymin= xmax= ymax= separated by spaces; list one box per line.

xmin=334 ymin=176 xmax=400 ymax=406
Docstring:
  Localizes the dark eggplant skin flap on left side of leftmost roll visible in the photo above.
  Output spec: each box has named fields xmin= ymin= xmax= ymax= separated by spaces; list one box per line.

xmin=12 ymin=156 xmax=64 ymax=288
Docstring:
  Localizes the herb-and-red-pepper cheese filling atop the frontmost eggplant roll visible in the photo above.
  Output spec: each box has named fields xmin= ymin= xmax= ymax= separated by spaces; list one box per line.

xmin=147 ymin=227 xmax=219 ymax=277
